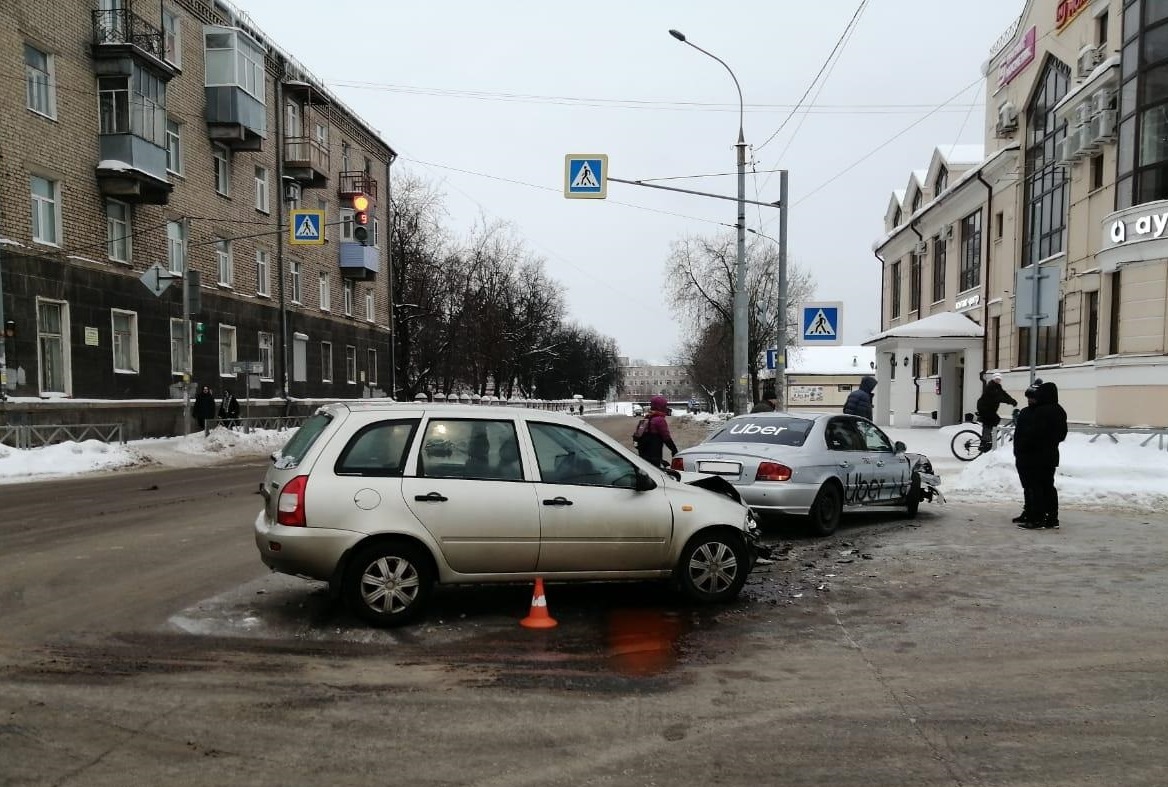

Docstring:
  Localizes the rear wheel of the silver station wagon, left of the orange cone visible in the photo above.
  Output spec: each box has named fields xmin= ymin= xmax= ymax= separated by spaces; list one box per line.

xmin=341 ymin=541 xmax=434 ymax=628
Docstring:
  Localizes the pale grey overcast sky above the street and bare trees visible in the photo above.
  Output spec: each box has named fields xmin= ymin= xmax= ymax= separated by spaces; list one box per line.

xmin=237 ymin=0 xmax=1024 ymax=361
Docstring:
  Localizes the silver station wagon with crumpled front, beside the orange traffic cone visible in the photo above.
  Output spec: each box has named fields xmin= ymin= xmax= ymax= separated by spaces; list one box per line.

xmin=255 ymin=402 xmax=758 ymax=626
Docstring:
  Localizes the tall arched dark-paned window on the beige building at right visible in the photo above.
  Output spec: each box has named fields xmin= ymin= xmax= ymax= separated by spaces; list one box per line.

xmin=1022 ymin=57 xmax=1070 ymax=267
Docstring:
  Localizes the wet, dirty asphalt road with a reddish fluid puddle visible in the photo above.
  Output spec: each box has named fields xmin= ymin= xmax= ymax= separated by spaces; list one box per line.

xmin=0 ymin=418 xmax=1168 ymax=786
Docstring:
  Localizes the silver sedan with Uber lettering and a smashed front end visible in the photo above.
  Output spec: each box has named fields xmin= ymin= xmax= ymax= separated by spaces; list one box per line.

xmin=673 ymin=412 xmax=940 ymax=535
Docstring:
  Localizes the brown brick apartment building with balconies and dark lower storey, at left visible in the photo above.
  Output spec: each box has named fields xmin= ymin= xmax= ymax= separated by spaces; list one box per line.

xmin=0 ymin=0 xmax=395 ymax=399
